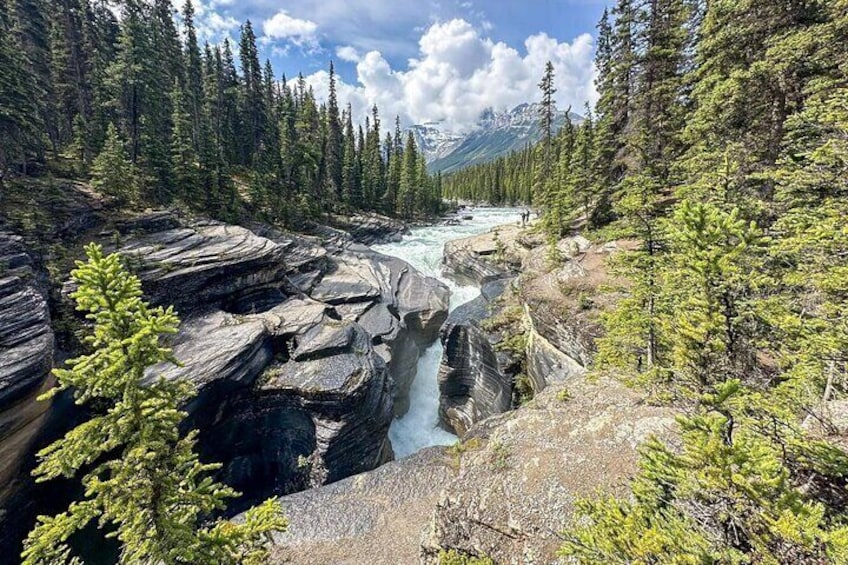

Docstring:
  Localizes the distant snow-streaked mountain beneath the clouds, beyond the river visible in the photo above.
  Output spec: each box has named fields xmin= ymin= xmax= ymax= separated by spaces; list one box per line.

xmin=409 ymin=103 xmax=582 ymax=172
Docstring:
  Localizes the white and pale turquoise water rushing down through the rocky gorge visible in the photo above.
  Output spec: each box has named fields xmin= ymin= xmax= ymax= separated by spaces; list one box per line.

xmin=373 ymin=208 xmax=521 ymax=459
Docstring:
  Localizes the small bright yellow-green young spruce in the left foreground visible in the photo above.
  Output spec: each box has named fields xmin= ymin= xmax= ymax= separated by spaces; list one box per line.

xmin=22 ymin=244 xmax=286 ymax=565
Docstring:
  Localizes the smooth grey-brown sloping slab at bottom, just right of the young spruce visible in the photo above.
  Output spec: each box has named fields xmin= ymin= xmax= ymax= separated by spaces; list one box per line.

xmin=269 ymin=447 xmax=455 ymax=565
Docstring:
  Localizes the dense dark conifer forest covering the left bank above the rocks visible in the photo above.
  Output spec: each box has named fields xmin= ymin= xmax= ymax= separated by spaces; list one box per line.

xmin=0 ymin=0 xmax=441 ymax=225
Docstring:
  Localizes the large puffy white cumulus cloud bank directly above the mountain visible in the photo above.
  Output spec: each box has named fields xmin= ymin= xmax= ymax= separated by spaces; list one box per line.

xmin=307 ymin=19 xmax=597 ymax=131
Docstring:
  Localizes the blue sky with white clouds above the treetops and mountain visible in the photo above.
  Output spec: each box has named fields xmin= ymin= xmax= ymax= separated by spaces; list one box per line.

xmin=191 ymin=0 xmax=606 ymax=132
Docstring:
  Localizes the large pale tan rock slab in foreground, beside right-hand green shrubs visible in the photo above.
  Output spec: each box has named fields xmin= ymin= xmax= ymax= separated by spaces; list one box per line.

xmin=422 ymin=377 xmax=675 ymax=565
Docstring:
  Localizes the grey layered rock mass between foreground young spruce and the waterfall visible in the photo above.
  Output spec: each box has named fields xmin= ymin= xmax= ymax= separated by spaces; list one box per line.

xmin=105 ymin=218 xmax=448 ymax=502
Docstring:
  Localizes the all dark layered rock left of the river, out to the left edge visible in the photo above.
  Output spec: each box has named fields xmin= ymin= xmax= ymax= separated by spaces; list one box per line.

xmin=0 ymin=185 xmax=449 ymax=551
